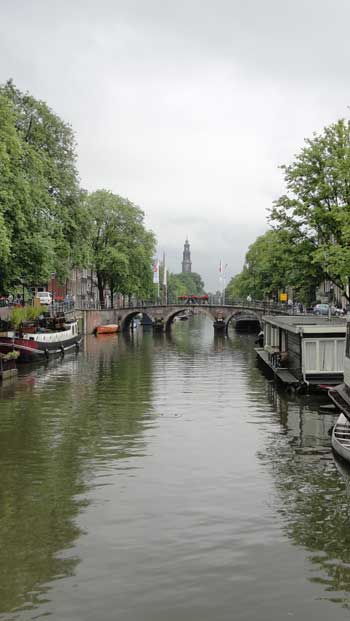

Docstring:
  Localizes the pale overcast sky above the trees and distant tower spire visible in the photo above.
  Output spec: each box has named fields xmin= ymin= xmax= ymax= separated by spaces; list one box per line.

xmin=0 ymin=0 xmax=350 ymax=290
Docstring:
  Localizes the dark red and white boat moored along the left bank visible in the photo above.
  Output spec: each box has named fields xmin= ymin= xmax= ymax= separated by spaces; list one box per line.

xmin=0 ymin=317 xmax=81 ymax=362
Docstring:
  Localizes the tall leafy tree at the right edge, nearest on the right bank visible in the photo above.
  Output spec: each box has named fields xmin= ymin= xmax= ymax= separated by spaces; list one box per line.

xmin=271 ymin=119 xmax=350 ymax=297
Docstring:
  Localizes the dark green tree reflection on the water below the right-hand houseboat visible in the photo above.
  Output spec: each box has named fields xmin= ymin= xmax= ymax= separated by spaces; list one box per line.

xmin=254 ymin=372 xmax=350 ymax=608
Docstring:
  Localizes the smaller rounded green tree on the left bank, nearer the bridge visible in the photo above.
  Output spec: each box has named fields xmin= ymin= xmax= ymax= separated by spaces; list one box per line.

xmin=86 ymin=190 xmax=155 ymax=304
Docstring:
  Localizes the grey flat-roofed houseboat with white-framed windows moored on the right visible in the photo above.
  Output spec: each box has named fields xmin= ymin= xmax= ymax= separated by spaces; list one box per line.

xmin=256 ymin=315 xmax=346 ymax=390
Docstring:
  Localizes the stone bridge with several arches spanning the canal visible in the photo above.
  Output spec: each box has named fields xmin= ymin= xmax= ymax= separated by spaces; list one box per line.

xmin=78 ymin=302 xmax=288 ymax=333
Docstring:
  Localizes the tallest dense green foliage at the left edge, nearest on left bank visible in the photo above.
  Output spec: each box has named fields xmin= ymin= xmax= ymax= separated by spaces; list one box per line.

xmin=0 ymin=81 xmax=86 ymax=291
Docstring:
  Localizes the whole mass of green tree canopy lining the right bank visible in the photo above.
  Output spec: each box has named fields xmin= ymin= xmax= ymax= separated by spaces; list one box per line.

xmin=227 ymin=119 xmax=350 ymax=302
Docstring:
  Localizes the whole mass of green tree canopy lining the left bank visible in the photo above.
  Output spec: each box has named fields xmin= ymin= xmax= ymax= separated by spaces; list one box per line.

xmin=0 ymin=81 xmax=155 ymax=301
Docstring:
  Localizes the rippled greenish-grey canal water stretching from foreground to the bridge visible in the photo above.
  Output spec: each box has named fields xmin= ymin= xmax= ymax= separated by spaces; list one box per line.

xmin=0 ymin=316 xmax=350 ymax=621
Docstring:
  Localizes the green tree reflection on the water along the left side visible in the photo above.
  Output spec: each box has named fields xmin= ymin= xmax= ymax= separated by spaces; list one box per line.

xmin=0 ymin=337 xmax=152 ymax=618
